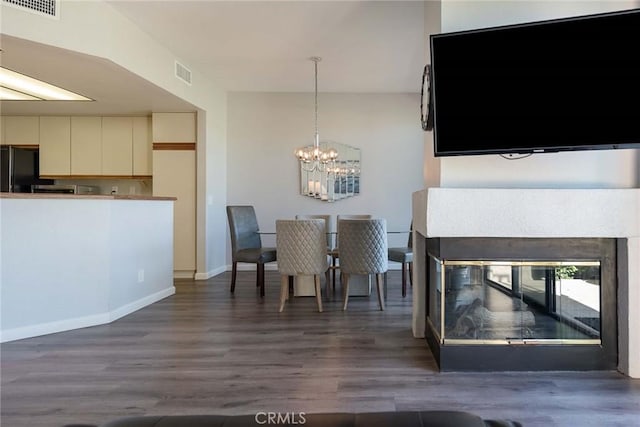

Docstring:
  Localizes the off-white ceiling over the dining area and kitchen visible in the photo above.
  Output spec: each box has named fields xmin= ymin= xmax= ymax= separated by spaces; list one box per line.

xmin=1 ymin=0 xmax=429 ymax=115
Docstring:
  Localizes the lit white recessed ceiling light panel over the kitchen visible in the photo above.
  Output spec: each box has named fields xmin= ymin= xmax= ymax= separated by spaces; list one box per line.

xmin=0 ymin=67 xmax=93 ymax=101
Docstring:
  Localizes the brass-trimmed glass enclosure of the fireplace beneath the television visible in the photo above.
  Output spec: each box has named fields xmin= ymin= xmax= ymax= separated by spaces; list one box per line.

xmin=429 ymin=257 xmax=601 ymax=344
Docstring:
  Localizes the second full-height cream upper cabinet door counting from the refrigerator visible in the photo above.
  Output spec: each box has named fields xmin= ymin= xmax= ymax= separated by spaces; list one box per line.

xmin=71 ymin=117 xmax=102 ymax=175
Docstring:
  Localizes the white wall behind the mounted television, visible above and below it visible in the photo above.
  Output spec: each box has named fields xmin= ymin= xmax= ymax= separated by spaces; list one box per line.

xmin=441 ymin=0 xmax=640 ymax=188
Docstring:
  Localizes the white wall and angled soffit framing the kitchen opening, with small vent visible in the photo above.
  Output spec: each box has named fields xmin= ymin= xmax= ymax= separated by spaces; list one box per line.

xmin=0 ymin=0 xmax=226 ymax=284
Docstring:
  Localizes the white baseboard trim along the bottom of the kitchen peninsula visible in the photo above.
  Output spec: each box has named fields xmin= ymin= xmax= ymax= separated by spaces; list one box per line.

xmin=0 ymin=286 xmax=176 ymax=342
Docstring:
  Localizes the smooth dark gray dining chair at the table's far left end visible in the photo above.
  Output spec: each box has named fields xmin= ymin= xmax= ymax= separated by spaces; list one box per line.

xmin=227 ymin=206 xmax=277 ymax=296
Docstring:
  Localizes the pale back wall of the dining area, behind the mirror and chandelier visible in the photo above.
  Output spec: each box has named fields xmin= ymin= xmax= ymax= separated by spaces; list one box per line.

xmin=227 ymin=93 xmax=424 ymax=262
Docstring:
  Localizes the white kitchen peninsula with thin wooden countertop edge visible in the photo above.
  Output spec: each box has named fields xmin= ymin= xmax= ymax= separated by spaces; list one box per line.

xmin=0 ymin=193 xmax=176 ymax=342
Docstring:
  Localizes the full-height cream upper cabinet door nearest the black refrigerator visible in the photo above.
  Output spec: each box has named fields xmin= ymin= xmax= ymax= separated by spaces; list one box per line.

xmin=39 ymin=117 xmax=71 ymax=176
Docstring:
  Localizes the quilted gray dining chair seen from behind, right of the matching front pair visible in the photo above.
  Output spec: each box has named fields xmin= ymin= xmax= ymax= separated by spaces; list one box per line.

xmin=338 ymin=219 xmax=389 ymax=310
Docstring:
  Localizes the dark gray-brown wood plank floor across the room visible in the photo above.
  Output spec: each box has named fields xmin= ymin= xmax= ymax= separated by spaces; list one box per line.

xmin=0 ymin=271 xmax=640 ymax=427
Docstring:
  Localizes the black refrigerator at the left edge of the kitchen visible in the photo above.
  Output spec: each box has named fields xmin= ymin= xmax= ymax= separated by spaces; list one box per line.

xmin=0 ymin=145 xmax=54 ymax=193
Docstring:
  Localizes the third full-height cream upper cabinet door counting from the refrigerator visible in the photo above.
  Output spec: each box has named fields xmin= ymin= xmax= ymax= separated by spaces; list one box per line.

xmin=102 ymin=117 xmax=133 ymax=176
